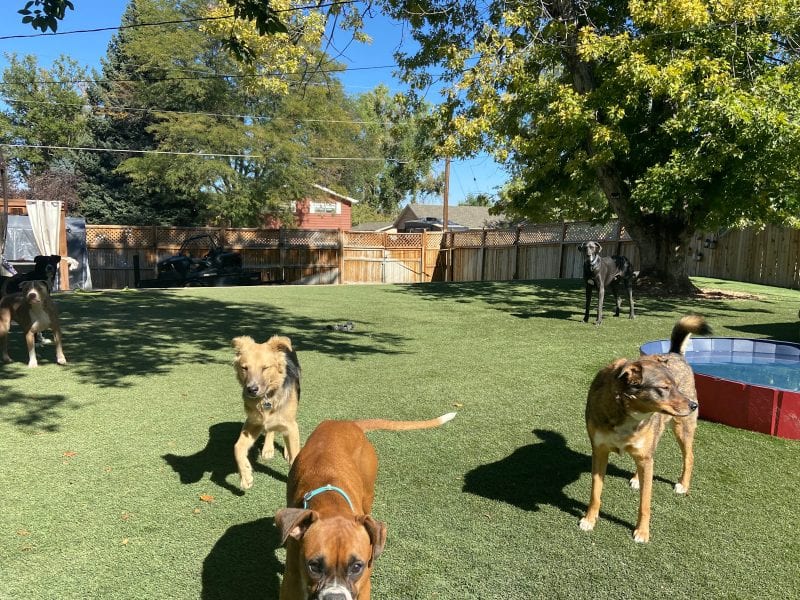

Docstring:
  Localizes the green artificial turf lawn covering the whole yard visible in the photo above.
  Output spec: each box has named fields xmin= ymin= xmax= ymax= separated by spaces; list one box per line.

xmin=0 ymin=280 xmax=800 ymax=600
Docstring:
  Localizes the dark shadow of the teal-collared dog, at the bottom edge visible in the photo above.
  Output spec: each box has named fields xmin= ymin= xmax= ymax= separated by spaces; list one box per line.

xmin=200 ymin=510 xmax=283 ymax=600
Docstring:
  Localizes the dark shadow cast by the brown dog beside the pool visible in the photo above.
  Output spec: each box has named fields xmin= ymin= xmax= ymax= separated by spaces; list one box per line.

xmin=463 ymin=429 xmax=667 ymax=528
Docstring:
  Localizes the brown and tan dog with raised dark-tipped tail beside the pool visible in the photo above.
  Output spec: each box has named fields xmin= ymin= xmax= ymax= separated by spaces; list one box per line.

xmin=580 ymin=316 xmax=711 ymax=542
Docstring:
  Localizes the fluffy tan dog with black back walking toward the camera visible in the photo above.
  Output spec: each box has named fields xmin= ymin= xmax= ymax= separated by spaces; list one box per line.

xmin=232 ymin=335 xmax=300 ymax=490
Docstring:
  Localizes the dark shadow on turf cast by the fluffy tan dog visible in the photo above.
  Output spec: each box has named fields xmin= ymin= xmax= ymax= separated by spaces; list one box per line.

xmin=161 ymin=422 xmax=286 ymax=496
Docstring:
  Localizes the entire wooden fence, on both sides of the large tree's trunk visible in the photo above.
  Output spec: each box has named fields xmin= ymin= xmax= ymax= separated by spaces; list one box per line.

xmin=86 ymin=222 xmax=800 ymax=288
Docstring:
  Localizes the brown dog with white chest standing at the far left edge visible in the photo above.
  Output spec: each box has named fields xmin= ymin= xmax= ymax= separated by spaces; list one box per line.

xmin=0 ymin=280 xmax=67 ymax=367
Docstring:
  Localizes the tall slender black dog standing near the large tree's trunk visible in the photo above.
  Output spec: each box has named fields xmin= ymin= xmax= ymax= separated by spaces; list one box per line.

xmin=578 ymin=242 xmax=637 ymax=325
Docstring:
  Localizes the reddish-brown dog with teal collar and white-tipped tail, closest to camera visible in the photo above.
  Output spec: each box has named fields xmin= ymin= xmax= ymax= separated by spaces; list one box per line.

xmin=275 ymin=413 xmax=455 ymax=600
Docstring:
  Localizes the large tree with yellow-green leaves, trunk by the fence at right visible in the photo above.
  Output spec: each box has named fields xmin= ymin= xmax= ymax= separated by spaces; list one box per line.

xmin=383 ymin=0 xmax=800 ymax=290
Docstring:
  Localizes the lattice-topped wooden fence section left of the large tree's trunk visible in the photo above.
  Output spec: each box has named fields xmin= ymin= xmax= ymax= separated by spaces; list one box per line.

xmin=86 ymin=223 xmax=636 ymax=289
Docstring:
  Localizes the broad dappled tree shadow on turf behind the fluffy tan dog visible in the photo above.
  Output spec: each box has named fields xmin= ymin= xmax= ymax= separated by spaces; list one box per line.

xmin=53 ymin=290 xmax=406 ymax=387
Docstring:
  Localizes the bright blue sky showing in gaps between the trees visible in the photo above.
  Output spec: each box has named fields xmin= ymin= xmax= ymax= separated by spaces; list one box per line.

xmin=0 ymin=0 xmax=506 ymax=204
